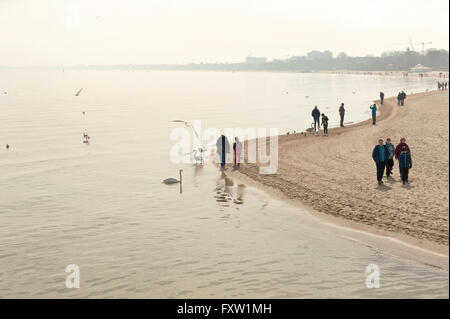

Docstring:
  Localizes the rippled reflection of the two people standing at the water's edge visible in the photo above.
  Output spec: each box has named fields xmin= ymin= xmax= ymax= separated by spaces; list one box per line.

xmin=214 ymin=172 xmax=245 ymax=207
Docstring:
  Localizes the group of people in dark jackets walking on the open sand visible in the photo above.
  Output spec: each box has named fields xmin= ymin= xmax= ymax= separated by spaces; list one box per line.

xmin=372 ymin=137 xmax=412 ymax=185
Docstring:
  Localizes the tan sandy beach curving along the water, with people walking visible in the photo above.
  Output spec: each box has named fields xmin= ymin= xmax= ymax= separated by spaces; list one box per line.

xmin=233 ymin=91 xmax=449 ymax=255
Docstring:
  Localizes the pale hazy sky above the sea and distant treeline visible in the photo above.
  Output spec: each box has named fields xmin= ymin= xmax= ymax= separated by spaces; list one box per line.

xmin=0 ymin=0 xmax=449 ymax=66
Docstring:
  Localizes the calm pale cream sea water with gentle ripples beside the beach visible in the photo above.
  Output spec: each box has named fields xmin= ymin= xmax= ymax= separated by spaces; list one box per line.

xmin=0 ymin=70 xmax=449 ymax=298
